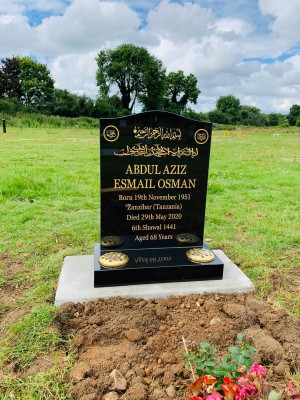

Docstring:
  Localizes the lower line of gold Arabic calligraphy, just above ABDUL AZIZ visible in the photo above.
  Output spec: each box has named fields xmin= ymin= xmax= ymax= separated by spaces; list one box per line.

xmin=114 ymin=143 xmax=198 ymax=158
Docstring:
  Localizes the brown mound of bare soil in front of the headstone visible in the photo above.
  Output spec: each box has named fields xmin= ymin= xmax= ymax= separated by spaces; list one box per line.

xmin=61 ymin=294 xmax=300 ymax=400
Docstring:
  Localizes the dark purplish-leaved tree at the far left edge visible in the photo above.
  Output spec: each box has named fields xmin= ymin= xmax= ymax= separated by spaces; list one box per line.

xmin=0 ymin=57 xmax=23 ymax=99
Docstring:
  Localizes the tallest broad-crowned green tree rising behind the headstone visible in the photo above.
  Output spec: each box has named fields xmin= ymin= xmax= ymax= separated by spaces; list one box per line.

xmin=96 ymin=44 xmax=165 ymax=111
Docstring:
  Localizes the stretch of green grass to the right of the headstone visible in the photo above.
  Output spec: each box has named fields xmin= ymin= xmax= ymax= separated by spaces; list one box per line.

xmin=206 ymin=129 xmax=300 ymax=310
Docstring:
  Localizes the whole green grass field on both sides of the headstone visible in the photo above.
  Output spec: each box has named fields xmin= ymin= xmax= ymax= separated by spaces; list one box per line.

xmin=0 ymin=127 xmax=300 ymax=400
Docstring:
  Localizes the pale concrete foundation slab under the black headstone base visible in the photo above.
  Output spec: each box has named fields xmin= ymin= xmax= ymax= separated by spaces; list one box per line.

xmin=55 ymin=250 xmax=255 ymax=306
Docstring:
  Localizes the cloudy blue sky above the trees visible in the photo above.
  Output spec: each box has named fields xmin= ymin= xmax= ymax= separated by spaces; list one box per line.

xmin=0 ymin=0 xmax=300 ymax=113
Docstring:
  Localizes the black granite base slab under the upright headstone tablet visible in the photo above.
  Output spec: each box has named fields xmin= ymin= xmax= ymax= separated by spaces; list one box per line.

xmin=94 ymin=243 xmax=224 ymax=287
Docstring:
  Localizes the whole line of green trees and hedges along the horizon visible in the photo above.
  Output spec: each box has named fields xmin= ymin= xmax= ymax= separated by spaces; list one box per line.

xmin=0 ymin=44 xmax=300 ymax=126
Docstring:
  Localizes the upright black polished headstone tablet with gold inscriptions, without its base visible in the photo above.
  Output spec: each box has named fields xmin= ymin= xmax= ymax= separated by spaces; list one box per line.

xmin=100 ymin=111 xmax=211 ymax=247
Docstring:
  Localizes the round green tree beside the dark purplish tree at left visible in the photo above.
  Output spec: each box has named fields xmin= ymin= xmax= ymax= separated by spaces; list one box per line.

xmin=18 ymin=57 xmax=54 ymax=105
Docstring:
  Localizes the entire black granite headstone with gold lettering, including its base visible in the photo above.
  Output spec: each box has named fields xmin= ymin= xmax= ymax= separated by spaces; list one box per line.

xmin=94 ymin=111 xmax=223 ymax=287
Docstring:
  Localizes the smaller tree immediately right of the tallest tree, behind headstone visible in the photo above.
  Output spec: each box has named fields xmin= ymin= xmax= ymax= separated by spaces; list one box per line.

xmin=165 ymin=70 xmax=200 ymax=113
